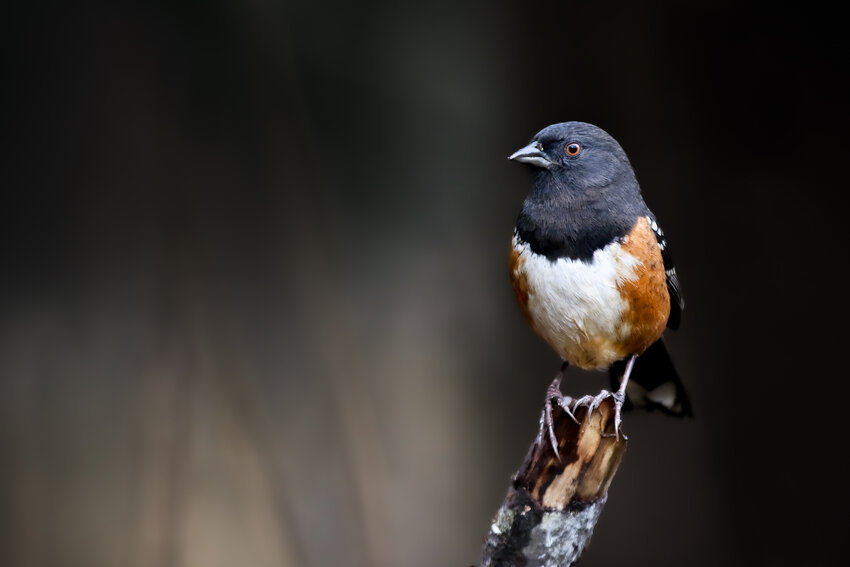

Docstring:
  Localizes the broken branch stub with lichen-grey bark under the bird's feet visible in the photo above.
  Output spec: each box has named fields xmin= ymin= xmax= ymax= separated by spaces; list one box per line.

xmin=478 ymin=398 xmax=626 ymax=567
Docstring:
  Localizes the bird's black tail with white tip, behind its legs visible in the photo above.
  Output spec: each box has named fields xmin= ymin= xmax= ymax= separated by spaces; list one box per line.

xmin=608 ymin=339 xmax=693 ymax=417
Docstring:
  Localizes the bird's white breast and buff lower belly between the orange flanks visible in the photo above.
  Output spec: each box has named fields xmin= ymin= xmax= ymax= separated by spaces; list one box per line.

xmin=513 ymin=235 xmax=641 ymax=368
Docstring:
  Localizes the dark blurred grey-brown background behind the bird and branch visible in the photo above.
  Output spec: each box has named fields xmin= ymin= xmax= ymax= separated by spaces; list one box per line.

xmin=0 ymin=0 xmax=850 ymax=567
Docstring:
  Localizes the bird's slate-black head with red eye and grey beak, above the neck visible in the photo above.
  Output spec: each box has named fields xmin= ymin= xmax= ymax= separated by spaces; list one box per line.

xmin=509 ymin=122 xmax=636 ymax=201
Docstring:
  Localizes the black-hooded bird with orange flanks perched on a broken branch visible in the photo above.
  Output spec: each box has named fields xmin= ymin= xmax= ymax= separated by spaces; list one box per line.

xmin=508 ymin=122 xmax=692 ymax=455
